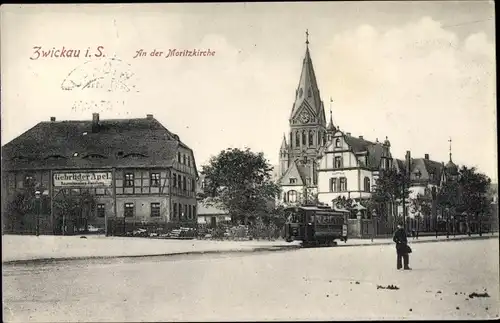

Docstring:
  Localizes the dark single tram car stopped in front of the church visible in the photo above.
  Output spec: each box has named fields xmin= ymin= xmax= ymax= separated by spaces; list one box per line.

xmin=285 ymin=206 xmax=349 ymax=247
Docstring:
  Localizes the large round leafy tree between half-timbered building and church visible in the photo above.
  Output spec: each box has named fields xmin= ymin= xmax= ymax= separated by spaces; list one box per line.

xmin=202 ymin=148 xmax=280 ymax=223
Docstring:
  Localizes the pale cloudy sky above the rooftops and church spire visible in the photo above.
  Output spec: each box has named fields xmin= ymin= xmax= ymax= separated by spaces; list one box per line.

xmin=0 ymin=1 xmax=497 ymax=182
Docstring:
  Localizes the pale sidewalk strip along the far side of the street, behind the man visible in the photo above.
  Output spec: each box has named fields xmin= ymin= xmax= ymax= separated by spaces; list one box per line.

xmin=2 ymin=233 xmax=498 ymax=264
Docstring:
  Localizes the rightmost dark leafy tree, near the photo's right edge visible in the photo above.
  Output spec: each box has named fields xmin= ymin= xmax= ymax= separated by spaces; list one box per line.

xmin=458 ymin=166 xmax=491 ymax=235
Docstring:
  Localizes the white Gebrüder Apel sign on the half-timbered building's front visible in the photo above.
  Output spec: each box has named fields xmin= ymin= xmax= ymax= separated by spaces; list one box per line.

xmin=53 ymin=172 xmax=113 ymax=187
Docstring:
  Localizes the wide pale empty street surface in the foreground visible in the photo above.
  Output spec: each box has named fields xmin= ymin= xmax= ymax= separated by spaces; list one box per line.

xmin=3 ymin=239 xmax=500 ymax=322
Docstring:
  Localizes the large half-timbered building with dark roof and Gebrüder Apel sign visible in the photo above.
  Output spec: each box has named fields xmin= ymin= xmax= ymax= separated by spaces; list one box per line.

xmin=2 ymin=113 xmax=198 ymax=232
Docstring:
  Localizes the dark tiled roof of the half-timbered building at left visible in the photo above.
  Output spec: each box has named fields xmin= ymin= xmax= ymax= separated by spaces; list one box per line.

xmin=2 ymin=118 xmax=189 ymax=170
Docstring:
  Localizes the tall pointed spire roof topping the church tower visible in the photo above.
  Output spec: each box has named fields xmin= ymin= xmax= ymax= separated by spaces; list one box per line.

xmin=290 ymin=32 xmax=324 ymax=120
